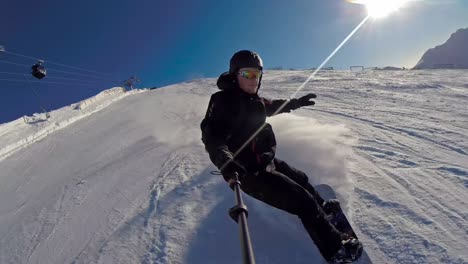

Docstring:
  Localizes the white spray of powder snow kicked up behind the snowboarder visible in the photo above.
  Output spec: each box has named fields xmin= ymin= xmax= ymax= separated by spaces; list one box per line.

xmin=269 ymin=114 xmax=356 ymax=208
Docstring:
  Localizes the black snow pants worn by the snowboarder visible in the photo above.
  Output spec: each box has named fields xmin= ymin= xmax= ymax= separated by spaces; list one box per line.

xmin=240 ymin=159 xmax=341 ymax=260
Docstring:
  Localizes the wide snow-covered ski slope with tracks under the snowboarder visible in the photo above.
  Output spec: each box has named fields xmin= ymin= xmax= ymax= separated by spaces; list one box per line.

xmin=0 ymin=70 xmax=468 ymax=264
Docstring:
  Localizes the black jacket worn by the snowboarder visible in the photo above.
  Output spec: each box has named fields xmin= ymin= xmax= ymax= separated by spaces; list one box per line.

xmin=201 ymin=74 xmax=300 ymax=179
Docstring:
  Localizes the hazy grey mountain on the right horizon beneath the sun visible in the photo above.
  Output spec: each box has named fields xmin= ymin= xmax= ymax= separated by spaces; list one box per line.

xmin=414 ymin=28 xmax=468 ymax=69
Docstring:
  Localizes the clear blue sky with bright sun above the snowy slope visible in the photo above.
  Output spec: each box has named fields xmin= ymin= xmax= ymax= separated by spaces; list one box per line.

xmin=0 ymin=0 xmax=468 ymax=123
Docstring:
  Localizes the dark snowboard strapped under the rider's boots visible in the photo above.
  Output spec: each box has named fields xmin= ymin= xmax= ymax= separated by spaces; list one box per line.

xmin=315 ymin=184 xmax=372 ymax=264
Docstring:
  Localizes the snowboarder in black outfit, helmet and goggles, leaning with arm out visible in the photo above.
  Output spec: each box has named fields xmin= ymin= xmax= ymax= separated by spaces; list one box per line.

xmin=201 ymin=50 xmax=362 ymax=263
